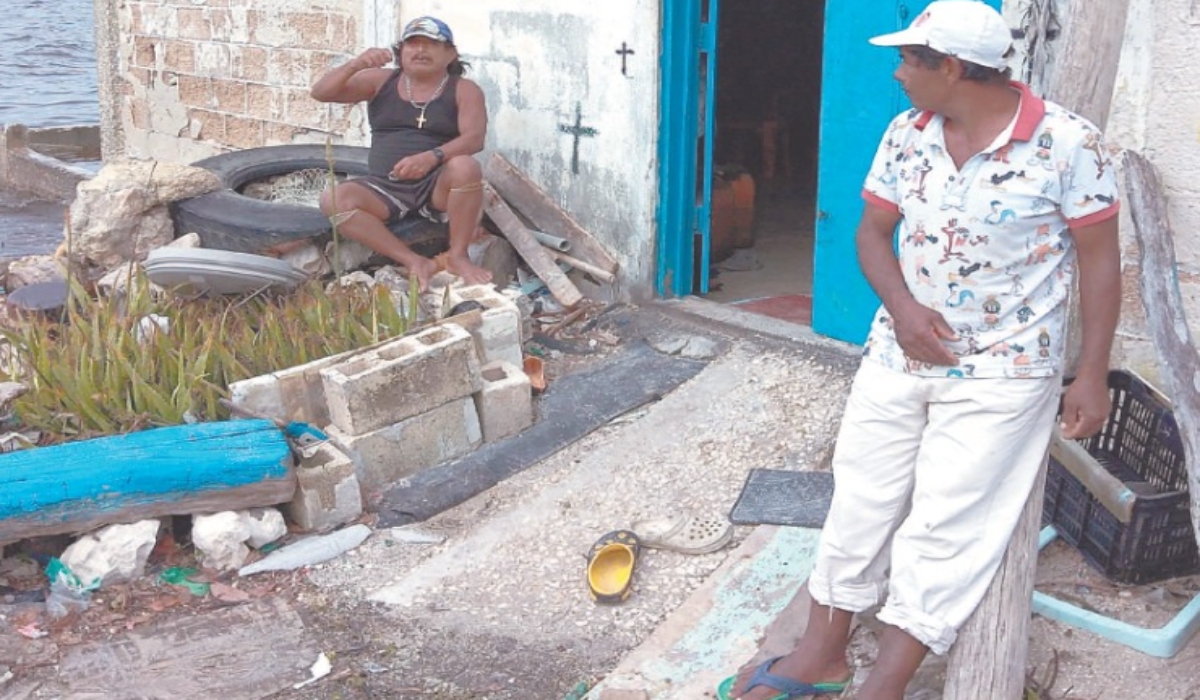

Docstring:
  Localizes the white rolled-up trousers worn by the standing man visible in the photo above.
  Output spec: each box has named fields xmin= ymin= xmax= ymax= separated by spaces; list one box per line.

xmin=809 ymin=359 xmax=1062 ymax=654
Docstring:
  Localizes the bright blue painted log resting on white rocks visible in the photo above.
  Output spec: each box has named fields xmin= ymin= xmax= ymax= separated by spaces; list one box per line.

xmin=0 ymin=419 xmax=295 ymax=544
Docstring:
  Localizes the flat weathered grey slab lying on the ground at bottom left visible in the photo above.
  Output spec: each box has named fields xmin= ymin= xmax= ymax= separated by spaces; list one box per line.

xmin=59 ymin=599 xmax=322 ymax=700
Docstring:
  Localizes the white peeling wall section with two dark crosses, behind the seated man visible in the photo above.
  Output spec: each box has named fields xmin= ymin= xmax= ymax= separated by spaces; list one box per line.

xmin=365 ymin=0 xmax=660 ymax=298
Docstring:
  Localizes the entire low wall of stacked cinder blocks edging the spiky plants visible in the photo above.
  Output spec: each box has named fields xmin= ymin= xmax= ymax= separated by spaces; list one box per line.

xmin=230 ymin=287 xmax=533 ymax=518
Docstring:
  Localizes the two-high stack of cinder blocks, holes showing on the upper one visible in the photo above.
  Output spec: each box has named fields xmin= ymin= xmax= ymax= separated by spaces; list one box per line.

xmin=320 ymin=324 xmax=484 ymax=492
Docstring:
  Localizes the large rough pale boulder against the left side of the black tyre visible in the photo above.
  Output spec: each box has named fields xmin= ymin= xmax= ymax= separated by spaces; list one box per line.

xmin=70 ymin=160 xmax=221 ymax=277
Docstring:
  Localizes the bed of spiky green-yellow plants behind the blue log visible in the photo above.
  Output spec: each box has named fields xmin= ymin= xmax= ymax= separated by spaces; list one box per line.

xmin=0 ymin=276 xmax=414 ymax=444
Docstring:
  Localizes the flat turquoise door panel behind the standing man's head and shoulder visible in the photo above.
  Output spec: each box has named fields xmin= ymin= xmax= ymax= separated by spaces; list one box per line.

xmin=812 ymin=0 xmax=1001 ymax=345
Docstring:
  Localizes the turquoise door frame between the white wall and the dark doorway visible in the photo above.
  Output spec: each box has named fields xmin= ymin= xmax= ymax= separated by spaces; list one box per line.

xmin=655 ymin=0 xmax=719 ymax=297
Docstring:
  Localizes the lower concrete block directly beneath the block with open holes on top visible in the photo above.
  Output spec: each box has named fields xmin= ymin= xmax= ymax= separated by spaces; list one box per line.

xmin=325 ymin=396 xmax=484 ymax=495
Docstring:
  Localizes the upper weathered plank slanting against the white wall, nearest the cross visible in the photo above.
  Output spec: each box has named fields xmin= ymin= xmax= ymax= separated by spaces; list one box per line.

xmin=484 ymin=152 xmax=618 ymax=273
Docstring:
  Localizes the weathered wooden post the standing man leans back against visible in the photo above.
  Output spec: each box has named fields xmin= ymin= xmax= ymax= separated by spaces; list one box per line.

xmin=942 ymin=0 xmax=1129 ymax=700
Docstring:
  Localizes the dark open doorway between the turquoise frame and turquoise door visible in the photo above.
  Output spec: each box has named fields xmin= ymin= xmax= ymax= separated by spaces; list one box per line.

xmin=707 ymin=0 xmax=824 ymax=324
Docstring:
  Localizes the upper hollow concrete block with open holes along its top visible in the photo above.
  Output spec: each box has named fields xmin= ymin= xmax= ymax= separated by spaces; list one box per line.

xmin=320 ymin=324 xmax=482 ymax=436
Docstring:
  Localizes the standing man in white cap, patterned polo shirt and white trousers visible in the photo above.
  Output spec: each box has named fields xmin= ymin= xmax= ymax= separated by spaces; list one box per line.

xmin=720 ymin=0 xmax=1121 ymax=700
